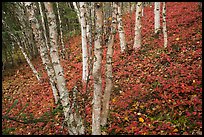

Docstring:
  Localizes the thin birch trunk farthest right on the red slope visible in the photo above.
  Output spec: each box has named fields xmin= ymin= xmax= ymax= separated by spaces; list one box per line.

xmin=162 ymin=2 xmax=167 ymax=48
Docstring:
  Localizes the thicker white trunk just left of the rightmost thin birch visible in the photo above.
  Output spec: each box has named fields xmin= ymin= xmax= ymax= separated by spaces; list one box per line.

xmin=154 ymin=2 xmax=160 ymax=34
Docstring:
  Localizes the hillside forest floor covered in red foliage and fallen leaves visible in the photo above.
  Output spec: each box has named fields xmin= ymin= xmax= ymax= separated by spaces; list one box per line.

xmin=2 ymin=2 xmax=202 ymax=135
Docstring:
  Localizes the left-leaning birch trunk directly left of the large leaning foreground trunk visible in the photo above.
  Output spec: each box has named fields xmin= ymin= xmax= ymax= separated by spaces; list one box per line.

xmin=25 ymin=2 xmax=59 ymax=104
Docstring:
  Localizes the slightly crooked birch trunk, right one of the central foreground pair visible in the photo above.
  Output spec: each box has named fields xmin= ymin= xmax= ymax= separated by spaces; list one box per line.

xmin=101 ymin=2 xmax=117 ymax=126
